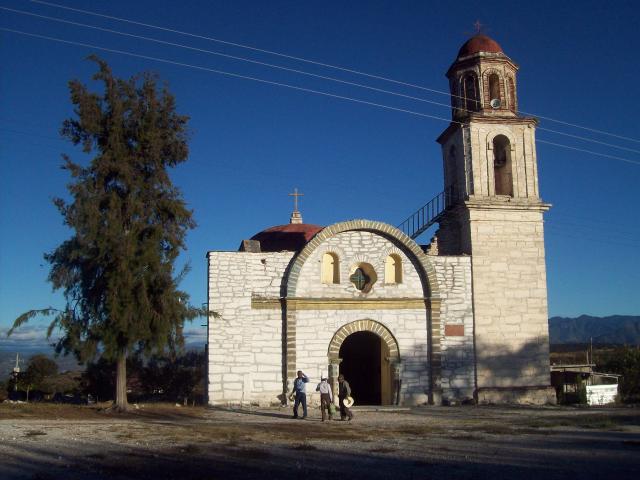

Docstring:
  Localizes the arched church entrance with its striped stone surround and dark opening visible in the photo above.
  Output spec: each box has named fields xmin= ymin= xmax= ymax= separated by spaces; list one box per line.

xmin=329 ymin=320 xmax=399 ymax=405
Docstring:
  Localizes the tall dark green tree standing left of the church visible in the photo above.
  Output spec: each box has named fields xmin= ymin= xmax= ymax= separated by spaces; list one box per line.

xmin=11 ymin=56 xmax=204 ymax=410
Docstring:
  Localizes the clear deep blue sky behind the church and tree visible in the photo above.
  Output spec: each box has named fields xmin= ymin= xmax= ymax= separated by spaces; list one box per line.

xmin=0 ymin=0 xmax=640 ymax=348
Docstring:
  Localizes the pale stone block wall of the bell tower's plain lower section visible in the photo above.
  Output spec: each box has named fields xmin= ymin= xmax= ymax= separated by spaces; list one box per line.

xmin=470 ymin=205 xmax=550 ymax=396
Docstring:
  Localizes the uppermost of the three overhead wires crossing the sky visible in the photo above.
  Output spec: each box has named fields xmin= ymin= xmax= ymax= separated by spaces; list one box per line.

xmin=29 ymin=0 xmax=640 ymax=143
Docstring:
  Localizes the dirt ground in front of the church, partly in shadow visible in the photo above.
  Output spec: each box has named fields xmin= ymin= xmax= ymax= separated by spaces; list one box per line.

xmin=0 ymin=404 xmax=640 ymax=480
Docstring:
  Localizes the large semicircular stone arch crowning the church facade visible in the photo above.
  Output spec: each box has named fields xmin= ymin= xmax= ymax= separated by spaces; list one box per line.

xmin=285 ymin=220 xmax=440 ymax=300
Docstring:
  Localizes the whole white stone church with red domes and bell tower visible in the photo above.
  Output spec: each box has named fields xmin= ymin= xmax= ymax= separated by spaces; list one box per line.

xmin=207 ymin=34 xmax=555 ymax=405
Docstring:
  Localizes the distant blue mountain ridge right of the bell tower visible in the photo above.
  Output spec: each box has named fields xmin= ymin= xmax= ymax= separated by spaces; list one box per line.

xmin=549 ymin=315 xmax=640 ymax=345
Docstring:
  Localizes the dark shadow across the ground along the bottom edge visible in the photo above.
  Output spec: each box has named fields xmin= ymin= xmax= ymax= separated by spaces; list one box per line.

xmin=0 ymin=432 xmax=640 ymax=480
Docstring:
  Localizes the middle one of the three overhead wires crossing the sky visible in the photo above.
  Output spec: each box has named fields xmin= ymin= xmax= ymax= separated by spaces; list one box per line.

xmin=5 ymin=6 xmax=640 ymax=153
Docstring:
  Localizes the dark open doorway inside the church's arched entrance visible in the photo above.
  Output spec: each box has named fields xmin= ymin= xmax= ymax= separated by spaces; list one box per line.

xmin=340 ymin=332 xmax=382 ymax=405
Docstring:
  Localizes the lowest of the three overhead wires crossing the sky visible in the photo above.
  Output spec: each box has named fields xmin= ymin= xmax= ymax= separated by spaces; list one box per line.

xmin=0 ymin=27 xmax=640 ymax=169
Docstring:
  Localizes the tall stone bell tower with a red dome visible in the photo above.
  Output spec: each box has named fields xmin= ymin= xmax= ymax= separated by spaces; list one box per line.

xmin=436 ymin=34 xmax=555 ymax=403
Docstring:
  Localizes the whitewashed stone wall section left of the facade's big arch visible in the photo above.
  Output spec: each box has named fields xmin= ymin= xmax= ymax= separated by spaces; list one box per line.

xmin=208 ymin=252 xmax=293 ymax=405
